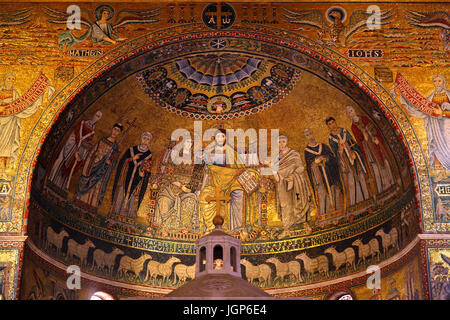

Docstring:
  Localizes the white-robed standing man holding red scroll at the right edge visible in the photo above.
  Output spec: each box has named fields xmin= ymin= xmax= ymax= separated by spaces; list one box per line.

xmin=392 ymin=74 xmax=450 ymax=180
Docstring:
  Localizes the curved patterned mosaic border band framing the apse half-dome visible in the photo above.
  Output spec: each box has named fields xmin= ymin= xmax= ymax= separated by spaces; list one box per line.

xmin=9 ymin=24 xmax=442 ymax=238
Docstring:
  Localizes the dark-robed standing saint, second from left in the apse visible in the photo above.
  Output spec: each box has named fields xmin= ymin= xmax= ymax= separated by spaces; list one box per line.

xmin=75 ymin=123 xmax=123 ymax=213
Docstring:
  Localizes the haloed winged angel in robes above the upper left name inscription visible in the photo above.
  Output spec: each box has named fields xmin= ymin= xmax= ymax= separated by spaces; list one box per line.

xmin=45 ymin=5 xmax=160 ymax=50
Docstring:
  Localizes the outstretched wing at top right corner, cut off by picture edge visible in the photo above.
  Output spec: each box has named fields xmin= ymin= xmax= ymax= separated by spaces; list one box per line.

xmin=406 ymin=10 xmax=450 ymax=50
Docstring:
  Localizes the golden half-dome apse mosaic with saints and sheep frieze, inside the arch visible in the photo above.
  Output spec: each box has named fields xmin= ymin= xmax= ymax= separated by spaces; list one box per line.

xmin=24 ymin=18 xmax=417 ymax=288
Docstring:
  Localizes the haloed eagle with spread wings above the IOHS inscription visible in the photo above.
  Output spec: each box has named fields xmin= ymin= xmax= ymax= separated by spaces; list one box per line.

xmin=283 ymin=7 xmax=392 ymax=45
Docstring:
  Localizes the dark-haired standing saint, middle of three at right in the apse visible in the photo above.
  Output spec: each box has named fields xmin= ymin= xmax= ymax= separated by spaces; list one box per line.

xmin=325 ymin=117 xmax=370 ymax=208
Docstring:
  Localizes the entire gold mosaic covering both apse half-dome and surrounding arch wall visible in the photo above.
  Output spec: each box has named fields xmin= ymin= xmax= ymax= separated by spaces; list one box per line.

xmin=0 ymin=3 xmax=450 ymax=298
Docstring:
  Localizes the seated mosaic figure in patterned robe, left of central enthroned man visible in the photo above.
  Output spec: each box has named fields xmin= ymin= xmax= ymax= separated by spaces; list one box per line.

xmin=154 ymin=136 xmax=204 ymax=232
